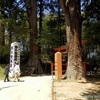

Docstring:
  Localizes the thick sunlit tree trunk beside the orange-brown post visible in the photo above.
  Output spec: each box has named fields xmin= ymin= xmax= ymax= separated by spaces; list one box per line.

xmin=60 ymin=0 xmax=85 ymax=80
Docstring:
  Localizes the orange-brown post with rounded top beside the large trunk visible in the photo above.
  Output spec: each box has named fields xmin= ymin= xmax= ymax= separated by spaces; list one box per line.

xmin=55 ymin=52 xmax=62 ymax=80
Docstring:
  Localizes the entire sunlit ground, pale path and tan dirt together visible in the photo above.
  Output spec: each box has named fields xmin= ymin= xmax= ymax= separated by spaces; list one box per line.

xmin=0 ymin=75 xmax=100 ymax=100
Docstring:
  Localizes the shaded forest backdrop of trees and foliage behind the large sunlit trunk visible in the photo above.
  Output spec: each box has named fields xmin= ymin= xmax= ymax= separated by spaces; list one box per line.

xmin=0 ymin=0 xmax=100 ymax=79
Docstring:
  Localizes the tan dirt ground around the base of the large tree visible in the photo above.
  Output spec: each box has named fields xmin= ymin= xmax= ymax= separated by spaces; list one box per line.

xmin=52 ymin=76 xmax=100 ymax=100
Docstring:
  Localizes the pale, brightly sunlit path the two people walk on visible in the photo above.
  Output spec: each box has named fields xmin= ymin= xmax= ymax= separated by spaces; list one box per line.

xmin=0 ymin=76 xmax=52 ymax=100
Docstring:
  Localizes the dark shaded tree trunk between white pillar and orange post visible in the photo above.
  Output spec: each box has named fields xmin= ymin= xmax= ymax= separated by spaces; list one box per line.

xmin=25 ymin=0 xmax=43 ymax=73
